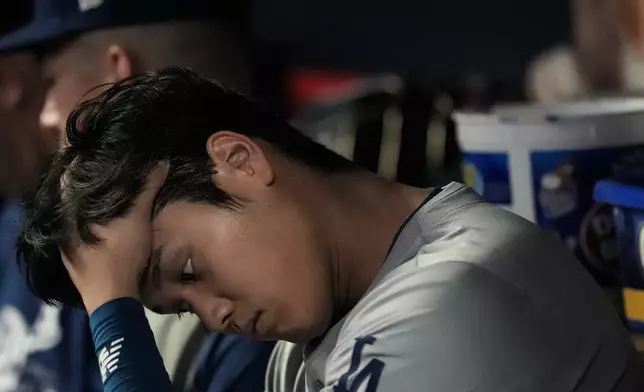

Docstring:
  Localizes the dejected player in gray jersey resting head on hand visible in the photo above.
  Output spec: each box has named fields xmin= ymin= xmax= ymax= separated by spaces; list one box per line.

xmin=19 ymin=69 xmax=644 ymax=392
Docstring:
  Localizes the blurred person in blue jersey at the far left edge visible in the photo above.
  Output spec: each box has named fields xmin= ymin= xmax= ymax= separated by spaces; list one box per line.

xmin=0 ymin=4 xmax=102 ymax=392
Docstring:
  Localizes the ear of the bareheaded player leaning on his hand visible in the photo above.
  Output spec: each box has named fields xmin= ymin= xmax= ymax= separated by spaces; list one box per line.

xmin=206 ymin=131 xmax=275 ymax=186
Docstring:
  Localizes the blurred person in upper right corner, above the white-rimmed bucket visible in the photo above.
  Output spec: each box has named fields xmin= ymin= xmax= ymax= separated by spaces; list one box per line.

xmin=527 ymin=0 xmax=644 ymax=104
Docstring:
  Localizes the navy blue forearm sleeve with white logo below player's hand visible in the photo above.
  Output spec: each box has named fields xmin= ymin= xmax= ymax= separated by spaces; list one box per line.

xmin=90 ymin=298 xmax=172 ymax=392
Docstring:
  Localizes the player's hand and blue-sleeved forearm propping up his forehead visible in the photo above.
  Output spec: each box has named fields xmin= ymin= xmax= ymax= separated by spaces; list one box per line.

xmin=52 ymin=163 xmax=172 ymax=392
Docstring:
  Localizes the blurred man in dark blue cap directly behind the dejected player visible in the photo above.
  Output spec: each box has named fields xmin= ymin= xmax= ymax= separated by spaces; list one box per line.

xmin=0 ymin=0 xmax=273 ymax=392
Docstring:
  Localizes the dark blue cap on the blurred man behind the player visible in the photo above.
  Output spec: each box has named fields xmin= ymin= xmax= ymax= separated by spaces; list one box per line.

xmin=0 ymin=0 xmax=248 ymax=52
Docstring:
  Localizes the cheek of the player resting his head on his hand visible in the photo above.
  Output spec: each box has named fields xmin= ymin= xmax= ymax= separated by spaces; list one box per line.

xmin=202 ymin=220 xmax=332 ymax=335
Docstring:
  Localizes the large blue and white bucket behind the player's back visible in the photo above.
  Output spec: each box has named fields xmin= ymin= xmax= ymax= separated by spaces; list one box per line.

xmin=455 ymin=98 xmax=644 ymax=285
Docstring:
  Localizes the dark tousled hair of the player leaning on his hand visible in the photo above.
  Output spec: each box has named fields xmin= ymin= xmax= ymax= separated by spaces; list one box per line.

xmin=18 ymin=68 xmax=356 ymax=306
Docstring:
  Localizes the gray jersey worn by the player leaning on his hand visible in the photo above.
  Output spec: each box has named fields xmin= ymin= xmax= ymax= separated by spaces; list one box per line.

xmin=268 ymin=183 xmax=644 ymax=392
